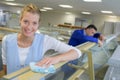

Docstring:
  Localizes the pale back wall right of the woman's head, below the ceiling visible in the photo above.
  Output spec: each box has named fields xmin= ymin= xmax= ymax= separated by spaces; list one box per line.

xmin=6 ymin=12 xmax=120 ymax=32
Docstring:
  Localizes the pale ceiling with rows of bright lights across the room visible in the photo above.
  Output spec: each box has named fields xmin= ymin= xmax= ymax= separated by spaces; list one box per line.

xmin=0 ymin=0 xmax=120 ymax=16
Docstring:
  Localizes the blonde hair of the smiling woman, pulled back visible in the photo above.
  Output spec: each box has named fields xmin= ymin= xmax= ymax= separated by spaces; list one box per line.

xmin=20 ymin=4 xmax=41 ymax=22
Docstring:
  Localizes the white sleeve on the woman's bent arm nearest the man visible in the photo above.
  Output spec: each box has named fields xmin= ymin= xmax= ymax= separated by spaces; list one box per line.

xmin=43 ymin=36 xmax=81 ymax=57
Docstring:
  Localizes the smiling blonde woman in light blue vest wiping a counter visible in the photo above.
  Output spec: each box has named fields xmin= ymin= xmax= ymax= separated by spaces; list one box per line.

xmin=2 ymin=4 xmax=81 ymax=74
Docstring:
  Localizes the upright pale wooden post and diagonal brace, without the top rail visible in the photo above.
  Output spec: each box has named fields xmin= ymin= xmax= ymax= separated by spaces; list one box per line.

xmin=68 ymin=50 xmax=95 ymax=80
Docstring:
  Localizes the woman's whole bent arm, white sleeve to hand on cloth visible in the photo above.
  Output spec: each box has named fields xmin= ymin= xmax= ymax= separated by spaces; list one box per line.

xmin=37 ymin=36 xmax=81 ymax=66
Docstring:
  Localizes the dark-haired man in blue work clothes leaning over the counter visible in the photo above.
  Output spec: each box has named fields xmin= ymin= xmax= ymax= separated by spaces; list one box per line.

xmin=62 ymin=24 xmax=105 ymax=80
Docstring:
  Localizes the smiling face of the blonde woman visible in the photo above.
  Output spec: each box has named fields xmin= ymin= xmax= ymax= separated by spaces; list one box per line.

xmin=20 ymin=12 xmax=40 ymax=37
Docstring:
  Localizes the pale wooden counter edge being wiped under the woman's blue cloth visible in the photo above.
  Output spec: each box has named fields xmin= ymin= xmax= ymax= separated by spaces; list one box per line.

xmin=3 ymin=62 xmax=66 ymax=80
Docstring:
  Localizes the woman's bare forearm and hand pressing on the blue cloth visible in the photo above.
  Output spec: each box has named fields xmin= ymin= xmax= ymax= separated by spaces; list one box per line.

xmin=37 ymin=49 xmax=79 ymax=67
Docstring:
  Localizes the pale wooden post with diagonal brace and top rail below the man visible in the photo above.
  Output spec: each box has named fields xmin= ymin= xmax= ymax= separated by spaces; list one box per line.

xmin=68 ymin=42 xmax=95 ymax=80
